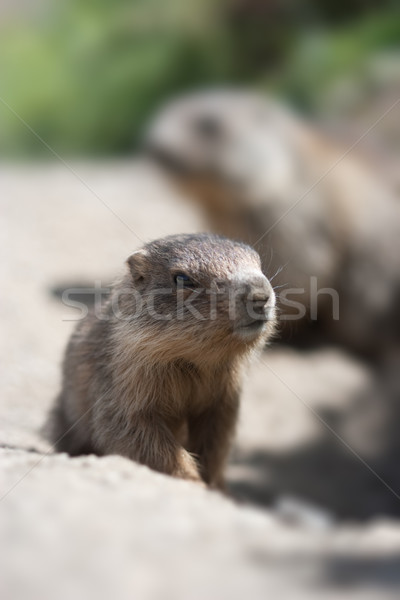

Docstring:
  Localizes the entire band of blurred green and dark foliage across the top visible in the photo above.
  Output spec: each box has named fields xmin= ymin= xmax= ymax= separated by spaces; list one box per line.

xmin=0 ymin=0 xmax=400 ymax=156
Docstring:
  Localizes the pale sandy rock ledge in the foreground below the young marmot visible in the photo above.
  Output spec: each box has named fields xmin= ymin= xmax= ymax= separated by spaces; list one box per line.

xmin=0 ymin=450 xmax=400 ymax=600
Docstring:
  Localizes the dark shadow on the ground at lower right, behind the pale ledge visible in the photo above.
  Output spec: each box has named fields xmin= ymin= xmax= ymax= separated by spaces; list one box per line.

xmin=230 ymin=366 xmax=400 ymax=520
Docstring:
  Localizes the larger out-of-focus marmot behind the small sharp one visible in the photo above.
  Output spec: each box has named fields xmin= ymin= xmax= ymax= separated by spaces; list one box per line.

xmin=146 ymin=91 xmax=400 ymax=357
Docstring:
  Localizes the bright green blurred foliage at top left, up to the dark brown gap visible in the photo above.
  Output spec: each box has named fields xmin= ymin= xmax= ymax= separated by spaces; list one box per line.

xmin=0 ymin=0 xmax=231 ymax=154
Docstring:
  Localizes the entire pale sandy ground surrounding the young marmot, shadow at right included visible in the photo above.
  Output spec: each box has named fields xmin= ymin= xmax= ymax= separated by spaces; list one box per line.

xmin=0 ymin=162 xmax=400 ymax=600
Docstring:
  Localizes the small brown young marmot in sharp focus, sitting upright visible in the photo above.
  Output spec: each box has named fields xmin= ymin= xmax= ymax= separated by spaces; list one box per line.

xmin=47 ymin=234 xmax=274 ymax=487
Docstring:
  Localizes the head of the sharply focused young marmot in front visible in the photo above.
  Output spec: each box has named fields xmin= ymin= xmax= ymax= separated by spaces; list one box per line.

xmin=120 ymin=234 xmax=275 ymax=362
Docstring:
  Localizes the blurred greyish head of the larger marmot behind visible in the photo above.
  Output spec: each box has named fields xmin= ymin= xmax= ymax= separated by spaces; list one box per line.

xmin=146 ymin=91 xmax=299 ymax=203
